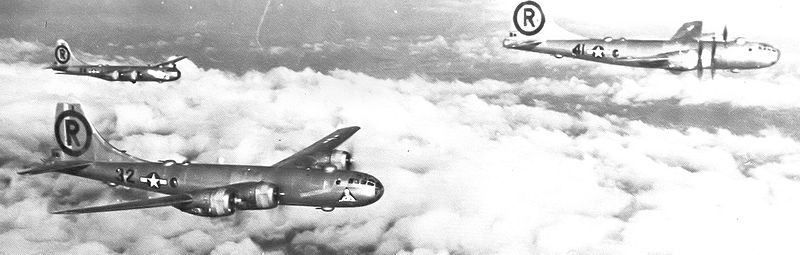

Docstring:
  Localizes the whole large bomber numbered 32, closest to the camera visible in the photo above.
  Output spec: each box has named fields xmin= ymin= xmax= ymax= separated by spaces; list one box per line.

xmin=20 ymin=103 xmax=383 ymax=217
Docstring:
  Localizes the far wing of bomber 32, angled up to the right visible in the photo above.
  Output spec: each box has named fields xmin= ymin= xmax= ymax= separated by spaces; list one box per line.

xmin=272 ymin=127 xmax=361 ymax=168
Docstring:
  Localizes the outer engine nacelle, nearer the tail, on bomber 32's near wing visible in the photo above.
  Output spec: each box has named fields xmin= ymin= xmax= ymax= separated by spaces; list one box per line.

xmin=175 ymin=188 xmax=236 ymax=217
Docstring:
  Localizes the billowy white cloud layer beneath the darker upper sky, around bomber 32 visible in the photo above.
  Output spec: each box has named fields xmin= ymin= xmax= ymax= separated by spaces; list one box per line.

xmin=0 ymin=37 xmax=800 ymax=254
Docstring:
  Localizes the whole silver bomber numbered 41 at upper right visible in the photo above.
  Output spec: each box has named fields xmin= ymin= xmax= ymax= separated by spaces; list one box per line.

xmin=503 ymin=1 xmax=780 ymax=78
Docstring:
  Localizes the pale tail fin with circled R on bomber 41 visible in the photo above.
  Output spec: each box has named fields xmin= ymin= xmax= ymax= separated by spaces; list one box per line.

xmin=503 ymin=1 xmax=586 ymax=45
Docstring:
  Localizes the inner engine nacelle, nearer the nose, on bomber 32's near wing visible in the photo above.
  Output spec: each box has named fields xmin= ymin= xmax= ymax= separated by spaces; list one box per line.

xmin=231 ymin=182 xmax=278 ymax=210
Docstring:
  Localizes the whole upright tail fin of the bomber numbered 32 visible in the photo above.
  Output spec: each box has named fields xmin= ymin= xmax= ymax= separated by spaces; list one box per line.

xmin=54 ymin=103 xmax=145 ymax=162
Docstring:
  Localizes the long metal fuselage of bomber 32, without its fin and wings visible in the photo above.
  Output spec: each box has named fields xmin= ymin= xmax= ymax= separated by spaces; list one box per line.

xmin=71 ymin=161 xmax=383 ymax=208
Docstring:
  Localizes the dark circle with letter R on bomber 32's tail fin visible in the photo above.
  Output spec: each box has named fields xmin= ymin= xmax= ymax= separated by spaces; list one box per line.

xmin=55 ymin=110 xmax=92 ymax=157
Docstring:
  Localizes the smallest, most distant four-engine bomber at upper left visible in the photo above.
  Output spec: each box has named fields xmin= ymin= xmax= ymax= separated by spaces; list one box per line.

xmin=48 ymin=39 xmax=186 ymax=83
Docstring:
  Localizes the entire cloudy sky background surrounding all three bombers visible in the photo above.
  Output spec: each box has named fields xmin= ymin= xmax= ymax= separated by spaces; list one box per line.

xmin=0 ymin=0 xmax=800 ymax=254
